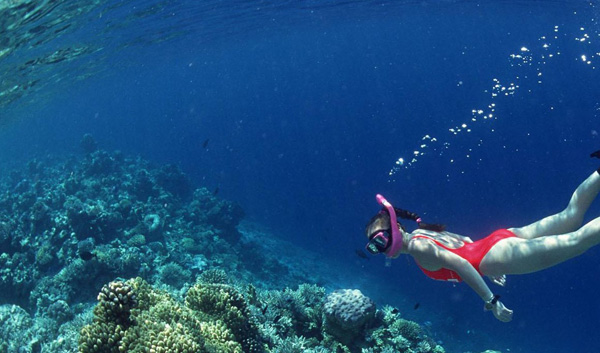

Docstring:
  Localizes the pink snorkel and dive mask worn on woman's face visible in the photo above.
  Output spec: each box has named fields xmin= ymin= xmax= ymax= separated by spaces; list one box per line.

xmin=366 ymin=194 xmax=402 ymax=258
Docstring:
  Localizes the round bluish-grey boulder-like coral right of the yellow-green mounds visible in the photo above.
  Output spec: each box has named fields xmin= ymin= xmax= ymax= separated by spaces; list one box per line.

xmin=323 ymin=289 xmax=375 ymax=341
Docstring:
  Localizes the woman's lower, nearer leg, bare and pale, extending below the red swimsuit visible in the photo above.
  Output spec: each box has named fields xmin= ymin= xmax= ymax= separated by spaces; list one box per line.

xmin=480 ymin=217 xmax=600 ymax=276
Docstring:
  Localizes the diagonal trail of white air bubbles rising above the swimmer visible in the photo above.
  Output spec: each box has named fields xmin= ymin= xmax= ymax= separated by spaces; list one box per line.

xmin=388 ymin=4 xmax=600 ymax=182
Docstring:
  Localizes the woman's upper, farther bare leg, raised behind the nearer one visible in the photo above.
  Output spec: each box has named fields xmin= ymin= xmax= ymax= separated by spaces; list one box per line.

xmin=510 ymin=171 xmax=600 ymax=239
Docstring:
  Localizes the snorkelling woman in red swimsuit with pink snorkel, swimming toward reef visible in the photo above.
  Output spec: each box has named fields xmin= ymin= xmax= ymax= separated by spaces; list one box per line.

xmin=366 ymin=165 xmax=600 ymax=322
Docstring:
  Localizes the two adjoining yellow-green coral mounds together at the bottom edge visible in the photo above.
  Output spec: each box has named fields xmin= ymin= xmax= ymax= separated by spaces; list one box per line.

xmin=79 ymin=278 xmax=262 ymax=353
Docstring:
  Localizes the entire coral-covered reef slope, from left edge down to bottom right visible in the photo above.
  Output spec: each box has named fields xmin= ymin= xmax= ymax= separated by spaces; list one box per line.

xmin=0 ymin=135 xmax=496 ymax=353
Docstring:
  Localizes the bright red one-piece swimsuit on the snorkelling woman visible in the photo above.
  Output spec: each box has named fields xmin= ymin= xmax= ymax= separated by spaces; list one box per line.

xmin=413 ymin=229 xmax=516 ymax=282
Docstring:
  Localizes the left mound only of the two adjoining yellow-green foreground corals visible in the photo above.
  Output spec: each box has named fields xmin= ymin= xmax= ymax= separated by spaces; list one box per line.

xmin=79 ymin=278 xmax=204 ymax=353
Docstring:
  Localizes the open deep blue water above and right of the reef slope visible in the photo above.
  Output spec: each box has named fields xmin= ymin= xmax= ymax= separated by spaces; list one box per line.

xmin=0 ymin=1 xmax=600 ymax=353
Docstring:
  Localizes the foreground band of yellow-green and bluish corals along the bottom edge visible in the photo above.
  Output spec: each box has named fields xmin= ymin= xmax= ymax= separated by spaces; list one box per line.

xmin=79 ymin=276 xmax=444 ymax=353
